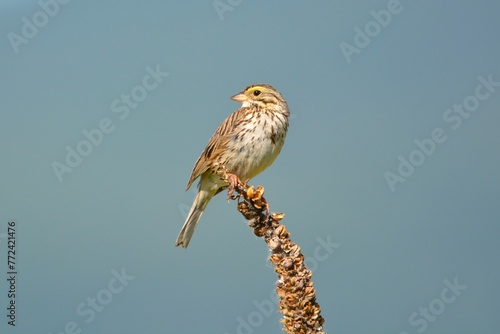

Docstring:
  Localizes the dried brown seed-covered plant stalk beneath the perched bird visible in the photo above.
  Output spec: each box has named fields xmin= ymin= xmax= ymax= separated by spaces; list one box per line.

xmin=233 ymin=186 xmax=325 ymax=334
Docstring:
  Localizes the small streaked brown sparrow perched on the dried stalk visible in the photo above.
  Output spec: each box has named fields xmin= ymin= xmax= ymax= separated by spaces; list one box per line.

xmin=175 ymin=83 xmax=290 ymax=248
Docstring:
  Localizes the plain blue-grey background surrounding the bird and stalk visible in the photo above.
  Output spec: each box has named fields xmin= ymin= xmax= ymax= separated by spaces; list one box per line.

xmin=0 ymin=0 xmax=500 ymax=334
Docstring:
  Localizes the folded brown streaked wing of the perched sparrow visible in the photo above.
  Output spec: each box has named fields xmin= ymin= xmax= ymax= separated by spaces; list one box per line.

xmin=186 ymin=108 xmax=247 ymax=190
